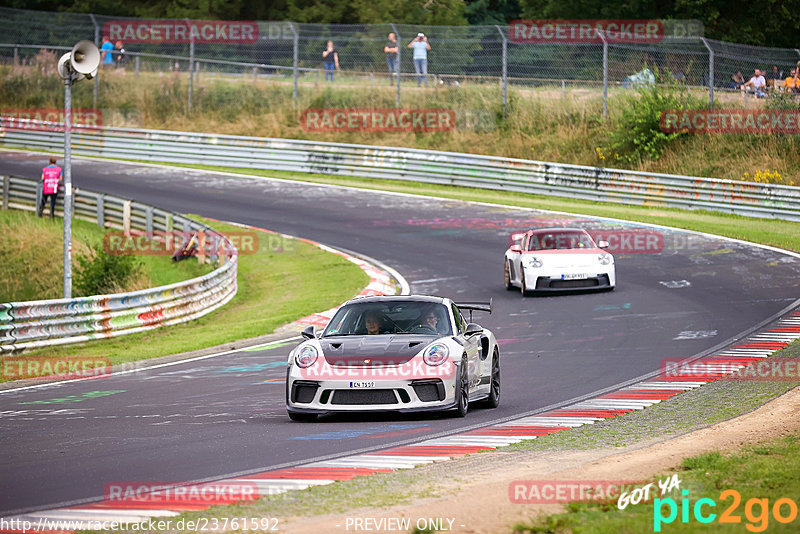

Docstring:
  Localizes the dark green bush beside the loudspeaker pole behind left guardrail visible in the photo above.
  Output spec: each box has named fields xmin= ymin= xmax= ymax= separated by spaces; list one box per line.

xmin=75 ymin=243 xmax=143 ymax=296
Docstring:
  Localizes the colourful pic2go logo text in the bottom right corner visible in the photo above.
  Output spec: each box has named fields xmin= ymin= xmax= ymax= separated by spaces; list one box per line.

xmin=653 ymin=489 xmax=797 ymax=532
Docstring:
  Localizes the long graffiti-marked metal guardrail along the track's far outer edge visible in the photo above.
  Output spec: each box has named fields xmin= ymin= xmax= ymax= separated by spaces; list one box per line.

xmin=0 ymin=117 xmax=800 ymax=221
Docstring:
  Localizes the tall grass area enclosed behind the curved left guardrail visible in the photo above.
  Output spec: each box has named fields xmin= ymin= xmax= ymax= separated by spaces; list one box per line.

xmin=0 ymin=208 xmax=211 ymax=302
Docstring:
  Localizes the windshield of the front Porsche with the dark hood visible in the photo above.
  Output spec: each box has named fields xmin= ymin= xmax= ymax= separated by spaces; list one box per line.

xmin=322 ymin=300 xmax=452 ymax=337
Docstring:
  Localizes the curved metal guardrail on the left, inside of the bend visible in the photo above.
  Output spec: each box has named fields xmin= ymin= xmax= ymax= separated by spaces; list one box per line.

xmin=0 ymin=176 xmax=238 ymax=353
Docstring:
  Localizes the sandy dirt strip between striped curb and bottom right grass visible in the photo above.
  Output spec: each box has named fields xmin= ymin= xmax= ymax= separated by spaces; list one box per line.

xmin=281 ymin=388 xmax=800 ymax=534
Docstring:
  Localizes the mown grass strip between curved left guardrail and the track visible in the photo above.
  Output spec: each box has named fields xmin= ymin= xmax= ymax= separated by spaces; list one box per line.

xmin=10 ymin=217 xmax=369 ymax=370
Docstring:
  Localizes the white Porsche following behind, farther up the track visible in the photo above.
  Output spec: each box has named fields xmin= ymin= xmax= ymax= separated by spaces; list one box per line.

xmin=504 ymin=228 xmax=616 ymax=295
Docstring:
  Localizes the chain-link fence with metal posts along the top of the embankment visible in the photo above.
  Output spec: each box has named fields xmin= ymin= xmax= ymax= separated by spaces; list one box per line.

xmin=0 ymin=8 xmax=800 ymax=111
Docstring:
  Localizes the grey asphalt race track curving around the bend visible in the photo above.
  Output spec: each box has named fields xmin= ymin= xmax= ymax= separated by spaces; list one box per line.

xmin=0 ymin=152 xmax=800 ymax=515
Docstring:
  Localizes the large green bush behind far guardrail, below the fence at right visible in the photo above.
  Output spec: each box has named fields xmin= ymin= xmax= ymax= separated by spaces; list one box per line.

xmin=608 ymin=78 xmax=705 ymax=163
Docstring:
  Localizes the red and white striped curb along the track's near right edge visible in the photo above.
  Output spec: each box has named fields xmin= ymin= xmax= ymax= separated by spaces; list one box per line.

xmin=11 ymin=308 xmax=800 ymax=528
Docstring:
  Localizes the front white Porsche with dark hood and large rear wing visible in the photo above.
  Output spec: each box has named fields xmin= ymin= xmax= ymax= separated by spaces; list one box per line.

xmin=286 ymin=296 xmax=500 ymax=421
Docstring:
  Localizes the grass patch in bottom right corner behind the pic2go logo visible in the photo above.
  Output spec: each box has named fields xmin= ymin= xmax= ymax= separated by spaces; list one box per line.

xmin=513 ymin=433 xmax=800 ymax=534
